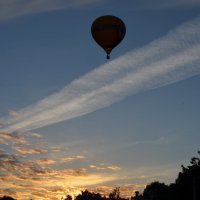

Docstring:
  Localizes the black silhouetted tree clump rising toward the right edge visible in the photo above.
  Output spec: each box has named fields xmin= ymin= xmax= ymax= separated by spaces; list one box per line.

xmin=132 ymin=151 xmax=200 ymax=200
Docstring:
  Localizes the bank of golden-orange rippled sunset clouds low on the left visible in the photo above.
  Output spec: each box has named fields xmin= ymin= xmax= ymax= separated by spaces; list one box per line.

xmin=0 ymin=132 xmax=128 ymax=200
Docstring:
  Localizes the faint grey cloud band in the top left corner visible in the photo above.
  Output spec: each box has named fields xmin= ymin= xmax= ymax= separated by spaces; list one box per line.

xmin=0 ymin=0 xmax=100 ymax=20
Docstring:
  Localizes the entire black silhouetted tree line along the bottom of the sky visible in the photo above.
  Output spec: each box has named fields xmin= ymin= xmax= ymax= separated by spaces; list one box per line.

xmin=0 ymin=151 xmax=200 ymax=200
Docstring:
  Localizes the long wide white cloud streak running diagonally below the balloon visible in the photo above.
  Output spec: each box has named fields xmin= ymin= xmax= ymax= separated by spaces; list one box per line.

xmin=0 ymin=17 xmax=200 ymax=132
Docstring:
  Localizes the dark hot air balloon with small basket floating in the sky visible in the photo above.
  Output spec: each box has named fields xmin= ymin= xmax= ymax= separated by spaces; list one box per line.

xmin=91 ymin=15 xmax=126 ymax=59
